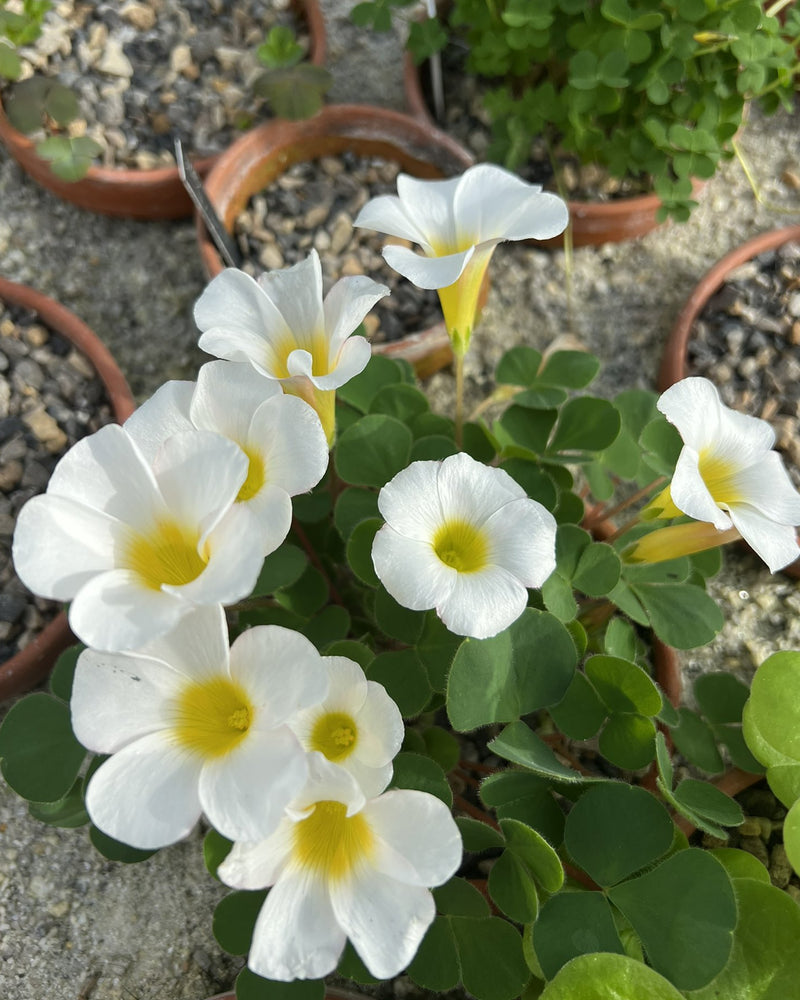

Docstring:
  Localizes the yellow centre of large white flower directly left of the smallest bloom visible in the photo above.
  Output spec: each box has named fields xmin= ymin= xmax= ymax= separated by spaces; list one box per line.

xmin=173 ymin=677 xmax=253 ymax=758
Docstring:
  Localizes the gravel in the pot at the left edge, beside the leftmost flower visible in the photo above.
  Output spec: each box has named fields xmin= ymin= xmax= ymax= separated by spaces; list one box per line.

xmin=0 ymin=302 xmax=113 ymax=663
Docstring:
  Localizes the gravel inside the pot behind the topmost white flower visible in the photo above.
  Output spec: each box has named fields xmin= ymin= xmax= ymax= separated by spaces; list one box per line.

xmin=234 ymin=152 xmax=442 ymax=342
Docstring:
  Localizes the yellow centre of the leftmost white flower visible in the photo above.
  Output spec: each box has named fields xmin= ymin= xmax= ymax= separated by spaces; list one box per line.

xmin=124 ymin=521 xmax=208 ymax=590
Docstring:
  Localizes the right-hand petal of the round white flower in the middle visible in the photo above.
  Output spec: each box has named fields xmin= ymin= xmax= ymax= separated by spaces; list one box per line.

xmin=484 ymin=497 xmax=556 ymax=587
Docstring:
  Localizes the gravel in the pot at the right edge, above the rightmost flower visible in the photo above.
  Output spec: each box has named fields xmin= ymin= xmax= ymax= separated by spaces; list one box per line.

xmin=689 ymin=243 xmax=800 ymax=487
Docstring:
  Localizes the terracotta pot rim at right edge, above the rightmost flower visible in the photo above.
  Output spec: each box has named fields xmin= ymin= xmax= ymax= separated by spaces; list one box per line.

xmin=658 ymin=226 xmax=800 ymax=577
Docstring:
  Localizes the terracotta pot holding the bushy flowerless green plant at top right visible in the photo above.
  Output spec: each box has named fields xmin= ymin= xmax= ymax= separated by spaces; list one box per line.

xmin=403 ymin=52 xmax=703 ymax=250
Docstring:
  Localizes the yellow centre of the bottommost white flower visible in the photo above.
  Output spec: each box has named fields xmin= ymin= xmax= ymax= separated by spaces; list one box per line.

xmin=293 ymin=801 xmax=375 ymax=879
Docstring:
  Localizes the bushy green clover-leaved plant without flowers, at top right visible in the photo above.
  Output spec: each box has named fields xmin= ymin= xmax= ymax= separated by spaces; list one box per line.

xmin=352 ymin=0 xmax=800 ymax=220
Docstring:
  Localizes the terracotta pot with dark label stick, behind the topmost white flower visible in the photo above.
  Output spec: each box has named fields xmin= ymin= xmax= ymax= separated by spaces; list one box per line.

xmin=197 ymin=104 xmax=472 ymax=377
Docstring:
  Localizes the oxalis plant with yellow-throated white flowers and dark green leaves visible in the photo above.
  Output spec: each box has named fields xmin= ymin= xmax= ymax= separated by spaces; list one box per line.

xmin=0 ymin=165 xmax=800 ymax=1000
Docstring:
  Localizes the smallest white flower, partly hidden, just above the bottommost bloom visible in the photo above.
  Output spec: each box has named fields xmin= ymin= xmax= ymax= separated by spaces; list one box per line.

xmin=289 ymin=656 xmax=405 ymax=798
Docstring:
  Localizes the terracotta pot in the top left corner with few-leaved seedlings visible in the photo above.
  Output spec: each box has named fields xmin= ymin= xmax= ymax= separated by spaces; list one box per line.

xmin=0 ymin=0 xmax=326 ymax=219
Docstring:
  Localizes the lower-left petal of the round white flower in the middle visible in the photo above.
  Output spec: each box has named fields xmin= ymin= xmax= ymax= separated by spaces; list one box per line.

xmin=372 ymin=524 xmax=458 ymax=611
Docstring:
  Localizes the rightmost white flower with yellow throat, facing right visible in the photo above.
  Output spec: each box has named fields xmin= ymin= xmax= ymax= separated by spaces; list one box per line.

xmin=646 ymin=378 xmax=800 ymax=573
